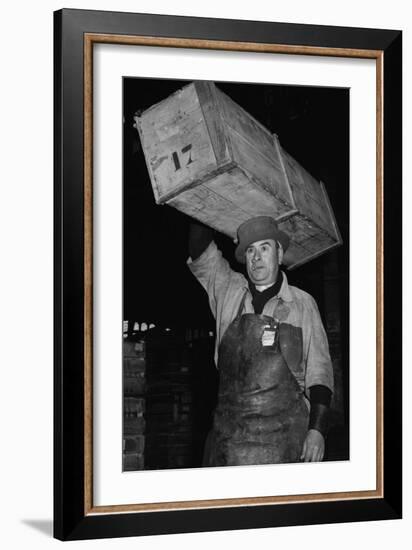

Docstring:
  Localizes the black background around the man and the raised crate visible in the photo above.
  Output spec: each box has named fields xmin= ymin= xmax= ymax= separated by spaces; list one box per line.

xmin=123 ymin=78 xmax=349 ymax=468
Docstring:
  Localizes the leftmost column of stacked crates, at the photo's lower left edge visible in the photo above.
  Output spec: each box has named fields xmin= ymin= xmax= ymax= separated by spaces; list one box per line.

xmin=123 ymin=339 xmax=146 ymax=471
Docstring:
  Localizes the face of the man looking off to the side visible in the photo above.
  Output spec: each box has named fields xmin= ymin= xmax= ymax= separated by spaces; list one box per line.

xmin=245 ymin=239 xmax=281 ymax=286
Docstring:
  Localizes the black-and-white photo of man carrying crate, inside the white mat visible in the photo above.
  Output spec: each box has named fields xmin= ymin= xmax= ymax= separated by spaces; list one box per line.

xmin=123 ymin=78 xmax=350 ymax=471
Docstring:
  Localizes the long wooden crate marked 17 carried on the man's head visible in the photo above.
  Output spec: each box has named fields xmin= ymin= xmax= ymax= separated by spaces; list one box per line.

xmin=135 ymin=81 xmax=342 ymax=269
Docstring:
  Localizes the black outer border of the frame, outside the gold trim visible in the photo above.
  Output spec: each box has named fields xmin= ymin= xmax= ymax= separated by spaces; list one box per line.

xmin=54 ymin=9 xmax=402 ymax=540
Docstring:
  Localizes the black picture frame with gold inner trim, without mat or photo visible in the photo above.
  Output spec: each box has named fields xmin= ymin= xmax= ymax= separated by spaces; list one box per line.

xmin=54 ymin=9 xmax=402 ymax=540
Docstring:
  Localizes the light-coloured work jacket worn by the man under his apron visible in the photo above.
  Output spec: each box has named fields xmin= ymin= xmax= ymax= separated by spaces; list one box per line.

xmin=187 ymin=242 xmax=333 ymax=396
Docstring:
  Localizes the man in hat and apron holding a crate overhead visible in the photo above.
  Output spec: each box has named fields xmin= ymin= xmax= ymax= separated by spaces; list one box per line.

xmin=188 ymin=216 xmax=333 ymax=466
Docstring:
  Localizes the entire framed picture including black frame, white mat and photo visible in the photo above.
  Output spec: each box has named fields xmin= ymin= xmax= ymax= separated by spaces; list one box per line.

xmin=54 ymin=9 xmax=402 ymax=540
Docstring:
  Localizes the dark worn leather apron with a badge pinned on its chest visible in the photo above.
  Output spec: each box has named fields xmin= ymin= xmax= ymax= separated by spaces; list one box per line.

xmin=203 ymin=293 xmax=309 ymax=466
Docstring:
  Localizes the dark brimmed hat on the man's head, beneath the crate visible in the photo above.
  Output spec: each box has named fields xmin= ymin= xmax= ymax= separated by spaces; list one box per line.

xmin=235 ymin=216 xmax=290 ymax=264
